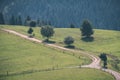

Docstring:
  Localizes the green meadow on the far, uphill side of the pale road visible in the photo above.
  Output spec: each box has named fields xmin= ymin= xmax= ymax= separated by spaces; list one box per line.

xmin=1 ymin=25 xmax=120 ymax=71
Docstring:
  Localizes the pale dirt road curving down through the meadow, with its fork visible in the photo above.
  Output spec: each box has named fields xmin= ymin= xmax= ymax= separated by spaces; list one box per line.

xmin=1 ymin=29 xmax=120 ymax=80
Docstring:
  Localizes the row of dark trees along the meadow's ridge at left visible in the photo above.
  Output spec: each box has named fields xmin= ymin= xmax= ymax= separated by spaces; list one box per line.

xmin=0 ymin=12 xmax=51 ymax=27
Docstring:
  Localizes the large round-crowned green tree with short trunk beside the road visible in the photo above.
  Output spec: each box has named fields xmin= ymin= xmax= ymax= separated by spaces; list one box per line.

xmin=40 ymin=26 xmax=54 ymax=42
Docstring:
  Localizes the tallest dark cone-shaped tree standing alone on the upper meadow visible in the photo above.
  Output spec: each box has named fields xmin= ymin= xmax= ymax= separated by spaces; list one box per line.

xmin=80 ymin=20 xmax=94 ymax=38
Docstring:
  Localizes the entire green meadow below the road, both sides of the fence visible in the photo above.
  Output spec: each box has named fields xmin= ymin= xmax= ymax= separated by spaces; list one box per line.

xmin=0 ymin=26 xmax=114 ymax=80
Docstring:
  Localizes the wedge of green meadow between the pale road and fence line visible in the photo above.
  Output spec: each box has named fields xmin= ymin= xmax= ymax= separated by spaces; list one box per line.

xmin=0 ymin=30 xmax=91 ymax=75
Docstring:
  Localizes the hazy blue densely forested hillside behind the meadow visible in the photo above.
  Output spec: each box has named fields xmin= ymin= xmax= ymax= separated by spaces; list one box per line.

xmin=0 ymin=0 xmax=120 ymax=30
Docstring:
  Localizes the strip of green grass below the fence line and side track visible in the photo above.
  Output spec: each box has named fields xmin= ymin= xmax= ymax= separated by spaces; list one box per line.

xmin=6 ymin=69 xmax=115 ymax=80
